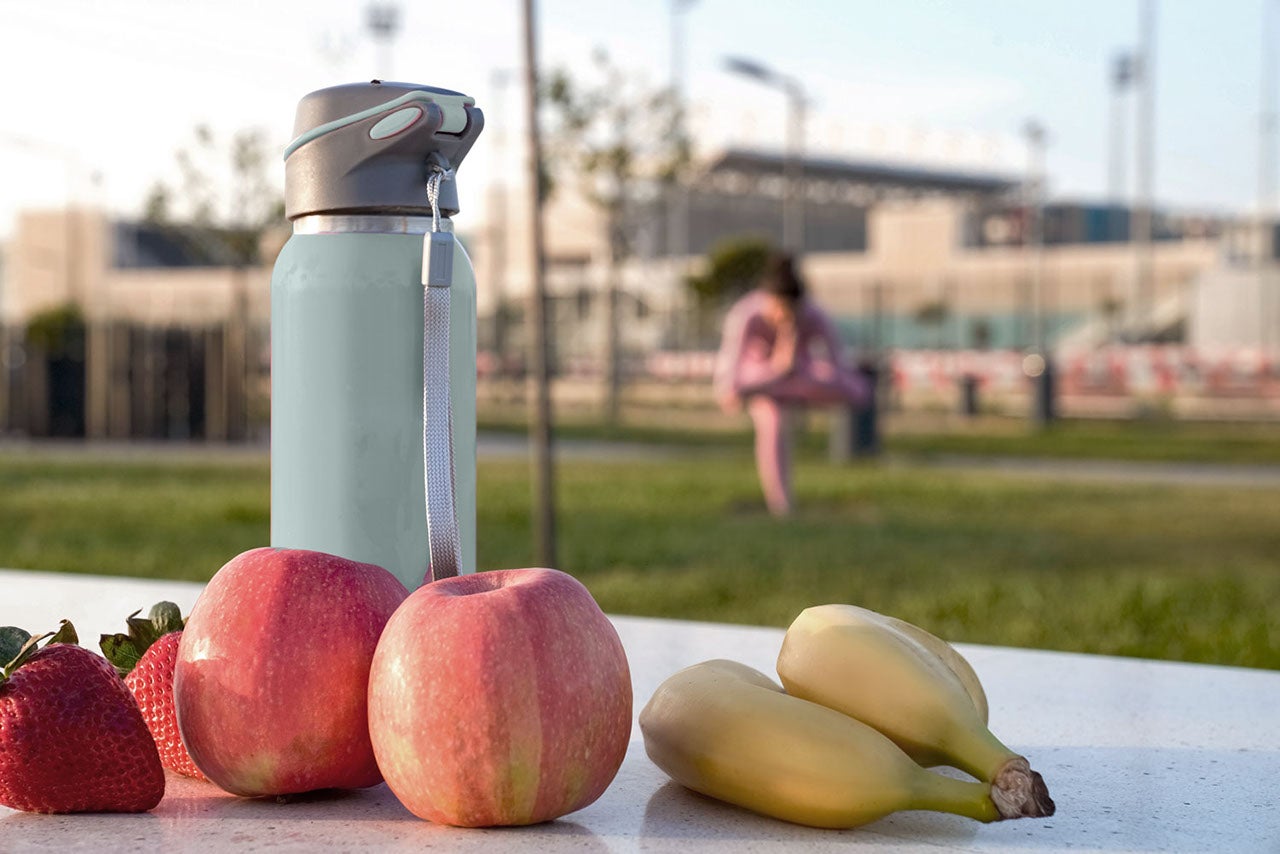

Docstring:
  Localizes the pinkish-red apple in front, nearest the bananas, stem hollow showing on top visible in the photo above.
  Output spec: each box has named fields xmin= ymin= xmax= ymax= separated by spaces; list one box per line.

xmin=369 ymin=568 xmax=631 ymax=827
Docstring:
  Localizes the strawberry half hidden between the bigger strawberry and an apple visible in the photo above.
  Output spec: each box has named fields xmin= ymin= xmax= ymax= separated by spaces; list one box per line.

xmin=100 ymin=602 xmax=209 ymax=780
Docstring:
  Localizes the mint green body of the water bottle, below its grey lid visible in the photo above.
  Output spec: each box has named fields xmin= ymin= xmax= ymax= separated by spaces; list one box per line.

xmin=271 ymin=224 xmax=476 ymax=590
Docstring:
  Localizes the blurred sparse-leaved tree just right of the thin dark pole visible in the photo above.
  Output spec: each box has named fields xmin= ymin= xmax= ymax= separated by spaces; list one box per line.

xmin=543 ymin=50 xmax=689 ymax=423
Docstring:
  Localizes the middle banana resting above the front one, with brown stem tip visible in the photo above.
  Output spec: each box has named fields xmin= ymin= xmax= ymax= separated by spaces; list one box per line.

xmin=778 ymin=604 xmax=1053 ymax=816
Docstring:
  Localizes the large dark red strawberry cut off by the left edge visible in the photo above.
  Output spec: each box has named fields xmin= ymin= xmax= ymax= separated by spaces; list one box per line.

xmin=0 ymin=620 xmax=164 ymax=813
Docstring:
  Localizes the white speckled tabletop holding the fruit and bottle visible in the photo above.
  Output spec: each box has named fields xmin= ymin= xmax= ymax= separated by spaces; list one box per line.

xmin=0 ymin=570 xmax=1280 ymax=854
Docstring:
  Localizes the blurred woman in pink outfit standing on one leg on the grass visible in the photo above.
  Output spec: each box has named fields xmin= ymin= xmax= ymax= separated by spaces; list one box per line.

xmin=714 ymin=255 xmax=870 ymax=516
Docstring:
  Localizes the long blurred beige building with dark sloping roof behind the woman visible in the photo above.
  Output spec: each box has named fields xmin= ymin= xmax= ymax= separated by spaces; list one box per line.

xmin=470 ymin=150 xmax=1264 ymax=364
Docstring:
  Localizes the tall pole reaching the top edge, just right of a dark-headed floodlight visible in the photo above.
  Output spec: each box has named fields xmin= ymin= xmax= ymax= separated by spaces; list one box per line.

xmin=1130 ymin=0 xmax=1156 ymax=337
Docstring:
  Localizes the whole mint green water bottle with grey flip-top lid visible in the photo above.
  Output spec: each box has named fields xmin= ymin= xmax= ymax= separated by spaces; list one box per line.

xmin=271 ymin=81 xmax=484 ymax=590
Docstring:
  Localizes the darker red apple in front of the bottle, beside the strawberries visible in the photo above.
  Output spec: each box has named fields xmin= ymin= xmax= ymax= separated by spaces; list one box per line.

xmin=173 ymin=548 xmax=408 ymax=796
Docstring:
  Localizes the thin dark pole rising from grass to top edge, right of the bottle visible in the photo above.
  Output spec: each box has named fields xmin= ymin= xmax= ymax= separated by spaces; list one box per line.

xmin=521 ymin=0 xmax=556 ymax=567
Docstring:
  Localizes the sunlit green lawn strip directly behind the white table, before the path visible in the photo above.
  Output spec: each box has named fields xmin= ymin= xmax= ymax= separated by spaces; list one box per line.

xmin=0 ymin=444 xmax=1280 ymax=668
